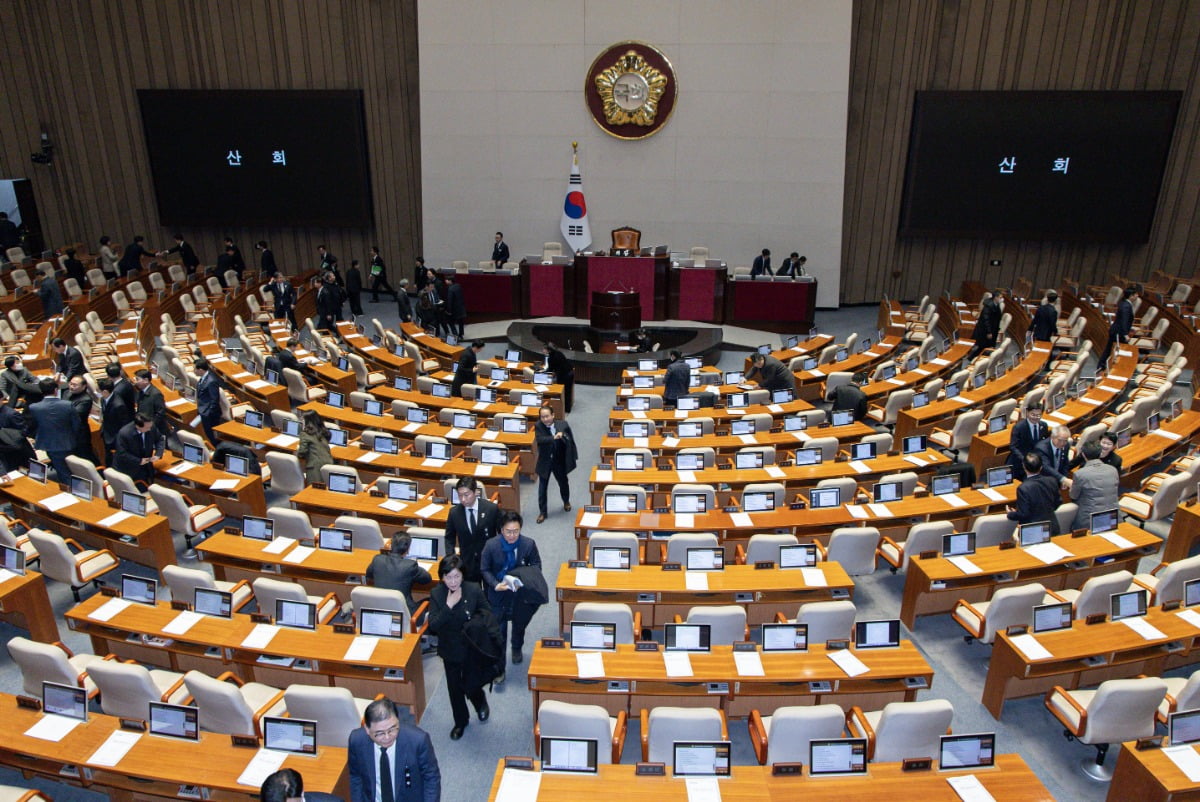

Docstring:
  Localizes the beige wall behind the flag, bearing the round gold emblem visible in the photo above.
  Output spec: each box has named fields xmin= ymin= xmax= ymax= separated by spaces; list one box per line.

xmin=418 ymin=0 xmax=851 ymax=306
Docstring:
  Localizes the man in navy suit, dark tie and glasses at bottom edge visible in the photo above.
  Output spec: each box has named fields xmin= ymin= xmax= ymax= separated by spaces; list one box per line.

xmin=347 ymin=699 xmax=442 ymax=802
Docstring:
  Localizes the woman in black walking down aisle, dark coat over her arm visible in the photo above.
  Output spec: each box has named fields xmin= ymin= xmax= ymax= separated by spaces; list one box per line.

xmin=430 ymin=555 xmax=491 ymax=741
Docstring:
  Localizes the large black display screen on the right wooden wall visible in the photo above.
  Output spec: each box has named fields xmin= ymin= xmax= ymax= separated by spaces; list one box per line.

xmin=900 ymin=91 xmax=1182 ymax=243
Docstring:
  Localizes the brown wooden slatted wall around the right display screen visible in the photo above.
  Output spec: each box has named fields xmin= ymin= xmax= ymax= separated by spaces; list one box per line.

xmin=841 ymin=0 xmax=1200 ymax=304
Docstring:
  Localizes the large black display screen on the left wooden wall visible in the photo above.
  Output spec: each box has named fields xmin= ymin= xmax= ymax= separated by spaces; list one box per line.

xmin=138 ymin=89 xmax=372 ymax=227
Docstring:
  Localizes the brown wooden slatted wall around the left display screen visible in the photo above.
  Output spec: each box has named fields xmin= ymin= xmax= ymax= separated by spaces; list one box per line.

xmin=0 ymin=0 xmax=421 ymax=283
